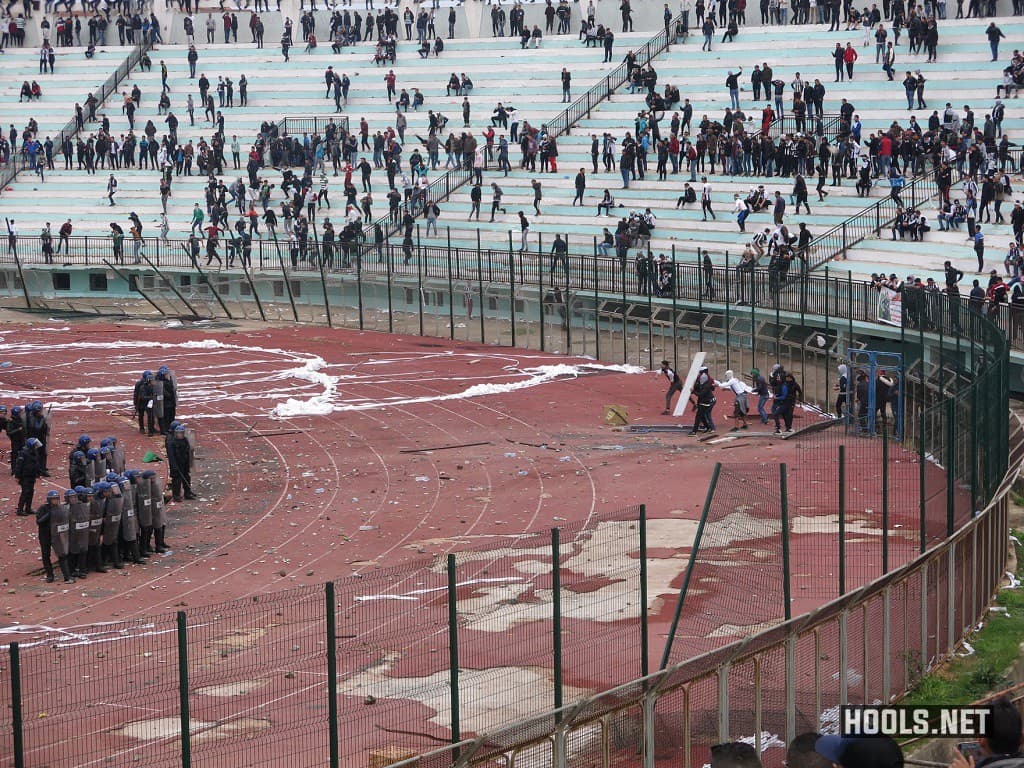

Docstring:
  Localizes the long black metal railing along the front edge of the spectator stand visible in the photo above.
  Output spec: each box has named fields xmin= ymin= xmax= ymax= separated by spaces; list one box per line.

xmin=14 ymin=237 xmax=1024 ymax=351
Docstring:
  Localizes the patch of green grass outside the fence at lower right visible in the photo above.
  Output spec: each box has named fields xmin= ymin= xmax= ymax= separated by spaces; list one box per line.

xmin=901 ymin=530 xmax=1024 ymax=705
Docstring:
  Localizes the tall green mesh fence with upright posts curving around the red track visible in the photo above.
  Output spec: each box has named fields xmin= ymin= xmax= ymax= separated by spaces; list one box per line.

xmin=0 ymin=252 xmax=1022 ymax=768
